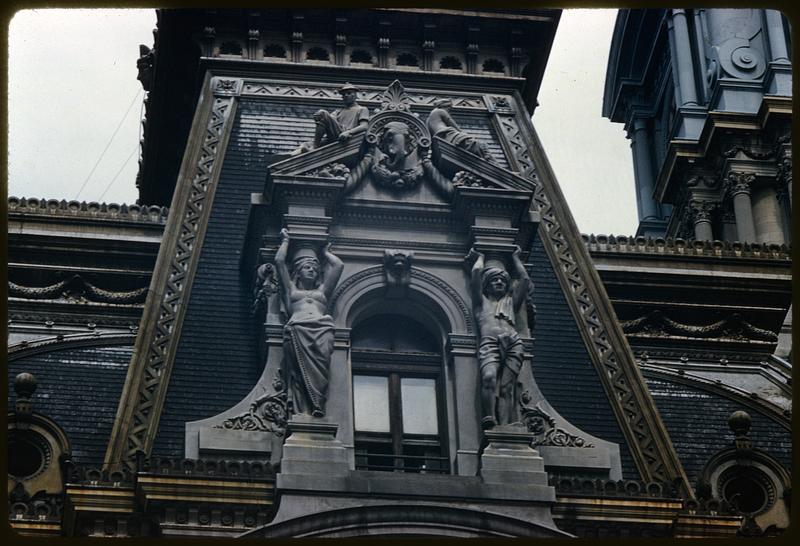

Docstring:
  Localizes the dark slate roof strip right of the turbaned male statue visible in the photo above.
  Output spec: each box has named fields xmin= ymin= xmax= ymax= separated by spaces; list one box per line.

xmin=531 ymin=238 xmax=639 ymax=479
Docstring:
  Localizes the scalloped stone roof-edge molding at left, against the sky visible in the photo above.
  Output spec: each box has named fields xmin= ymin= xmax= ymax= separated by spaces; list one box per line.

xmin=8 ymin=196 xmax=169 ymax=225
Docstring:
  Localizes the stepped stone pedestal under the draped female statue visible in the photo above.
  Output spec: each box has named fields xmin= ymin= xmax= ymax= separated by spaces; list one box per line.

xmin=280 ymin=415 xmax=350 ymax=476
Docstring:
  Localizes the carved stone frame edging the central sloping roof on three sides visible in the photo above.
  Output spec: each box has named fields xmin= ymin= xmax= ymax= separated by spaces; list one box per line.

xmin=106 ymin=74 xmax=692 ymax=495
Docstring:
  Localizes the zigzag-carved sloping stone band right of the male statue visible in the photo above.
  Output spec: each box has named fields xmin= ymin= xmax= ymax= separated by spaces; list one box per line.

xmin=497 ymin=104 xmax=690 ymax=491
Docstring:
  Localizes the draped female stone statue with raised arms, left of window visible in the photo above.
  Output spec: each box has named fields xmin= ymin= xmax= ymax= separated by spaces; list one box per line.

xmin=275 ymin=228 xmax=344 ymax=417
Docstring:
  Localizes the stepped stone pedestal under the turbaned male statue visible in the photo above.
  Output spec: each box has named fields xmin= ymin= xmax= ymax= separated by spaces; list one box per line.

xmin=480 ymin=426 xmax=547 ymax=486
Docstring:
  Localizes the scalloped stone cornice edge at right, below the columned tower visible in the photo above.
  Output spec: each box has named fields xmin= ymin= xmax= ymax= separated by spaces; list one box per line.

xmin=581 ymin=233 xmax=792 ymax=264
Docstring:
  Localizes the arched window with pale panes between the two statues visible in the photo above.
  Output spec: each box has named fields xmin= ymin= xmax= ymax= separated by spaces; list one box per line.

xmin=351 ymin=314 xmax=450 ymax=474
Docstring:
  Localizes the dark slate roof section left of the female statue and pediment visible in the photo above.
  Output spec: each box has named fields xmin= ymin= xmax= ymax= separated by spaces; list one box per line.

xmin=152 ymin=101 xmax=272 ymax=450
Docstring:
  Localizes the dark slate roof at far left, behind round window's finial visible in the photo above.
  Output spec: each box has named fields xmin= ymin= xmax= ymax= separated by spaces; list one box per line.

xmin=8 ymin=345 xmax=133 ymax=465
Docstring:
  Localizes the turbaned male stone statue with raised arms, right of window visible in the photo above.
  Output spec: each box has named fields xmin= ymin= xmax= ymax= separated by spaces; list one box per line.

xmin=466 ymin=247 xmax=530 ymax=429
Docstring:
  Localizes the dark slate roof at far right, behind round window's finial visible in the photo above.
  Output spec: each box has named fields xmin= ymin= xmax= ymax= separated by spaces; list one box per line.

xmin=647 ymin=378 xmax=792 ymax=484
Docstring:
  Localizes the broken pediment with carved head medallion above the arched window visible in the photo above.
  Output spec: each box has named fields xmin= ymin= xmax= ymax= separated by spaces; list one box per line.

xmin=265 ymin=80 xmax=535 ymax=224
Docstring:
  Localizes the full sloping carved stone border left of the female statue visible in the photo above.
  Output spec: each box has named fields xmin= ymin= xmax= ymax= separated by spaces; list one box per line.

xmin=105 ymin=75 xmax=236 ymax=468
